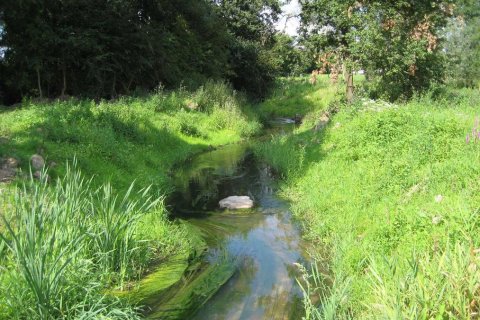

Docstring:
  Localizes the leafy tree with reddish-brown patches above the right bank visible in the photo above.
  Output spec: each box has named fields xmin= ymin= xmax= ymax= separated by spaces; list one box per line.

xmin=301 ymin=0 xmax=453 ymax=100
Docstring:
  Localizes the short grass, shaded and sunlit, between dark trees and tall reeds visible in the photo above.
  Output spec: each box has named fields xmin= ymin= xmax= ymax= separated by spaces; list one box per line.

xmin=0 ymin=83 xmax=260 ymax=194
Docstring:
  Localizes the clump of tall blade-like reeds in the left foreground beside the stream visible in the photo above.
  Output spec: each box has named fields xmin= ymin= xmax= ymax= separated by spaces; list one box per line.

xmin=0 ymin=166 xmax=190 ymax=319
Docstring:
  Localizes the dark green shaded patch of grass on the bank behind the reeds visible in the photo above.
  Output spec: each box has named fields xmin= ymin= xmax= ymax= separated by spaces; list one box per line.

xmin=0 ymin=101 xmax=205 ymax=192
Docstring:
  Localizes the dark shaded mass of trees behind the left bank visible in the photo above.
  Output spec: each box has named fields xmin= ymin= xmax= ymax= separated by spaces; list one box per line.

xmin=0 ymin=0 xmax=288 ymax=103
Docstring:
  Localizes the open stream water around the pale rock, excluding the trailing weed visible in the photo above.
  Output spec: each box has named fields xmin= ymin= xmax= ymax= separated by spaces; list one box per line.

xmin=170 ymin=126 xmax=306 ymax=320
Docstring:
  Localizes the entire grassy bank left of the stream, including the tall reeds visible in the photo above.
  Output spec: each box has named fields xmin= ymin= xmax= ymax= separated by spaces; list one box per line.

xmin=0 ymin=83 xmax=260 ymax=319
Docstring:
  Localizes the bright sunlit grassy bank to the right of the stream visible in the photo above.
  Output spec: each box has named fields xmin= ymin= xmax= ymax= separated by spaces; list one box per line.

xmin=257 ymin=77 xmax=480 ymax=319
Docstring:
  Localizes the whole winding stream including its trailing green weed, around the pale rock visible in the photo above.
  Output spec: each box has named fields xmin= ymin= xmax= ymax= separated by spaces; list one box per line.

xmin=134 ymin=119 xmax=308 ymax=320
